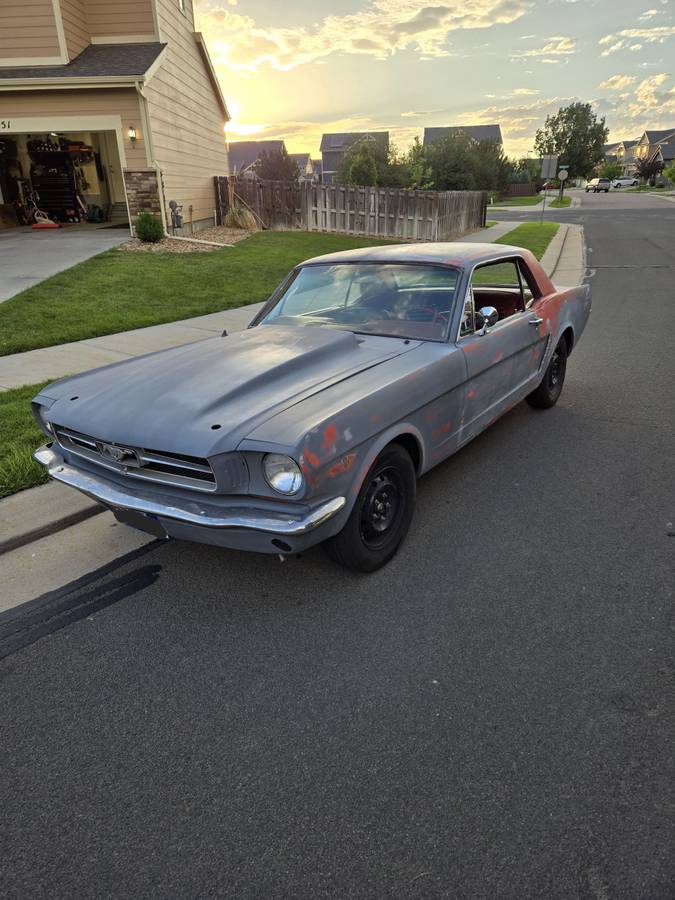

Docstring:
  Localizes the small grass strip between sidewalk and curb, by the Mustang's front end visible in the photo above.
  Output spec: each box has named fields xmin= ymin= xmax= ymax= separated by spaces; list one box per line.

xmin=0 ymin=382 xmax=48 ymax=497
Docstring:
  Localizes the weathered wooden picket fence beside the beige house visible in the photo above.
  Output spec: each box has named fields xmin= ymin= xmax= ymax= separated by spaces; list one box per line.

xmin=215 ymin=176 xmax=487 ymax=241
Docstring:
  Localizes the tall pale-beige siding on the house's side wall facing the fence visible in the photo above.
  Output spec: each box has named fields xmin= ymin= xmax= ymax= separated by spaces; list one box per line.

xmin=144 ymin=0 xmax=228 ymax=221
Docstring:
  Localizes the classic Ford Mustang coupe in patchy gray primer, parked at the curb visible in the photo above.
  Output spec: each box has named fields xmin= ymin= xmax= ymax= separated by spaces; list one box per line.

xmin=33 ymin=243 xmax=591 ymax=572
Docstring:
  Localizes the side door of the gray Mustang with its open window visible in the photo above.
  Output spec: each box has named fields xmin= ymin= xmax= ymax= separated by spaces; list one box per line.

xmin=458 ymin=257 xmax=546 ymax=441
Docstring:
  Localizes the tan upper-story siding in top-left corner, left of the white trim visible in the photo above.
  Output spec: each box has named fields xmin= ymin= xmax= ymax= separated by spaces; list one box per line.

xmin=0 ymin=0 xmax=61 ymax=59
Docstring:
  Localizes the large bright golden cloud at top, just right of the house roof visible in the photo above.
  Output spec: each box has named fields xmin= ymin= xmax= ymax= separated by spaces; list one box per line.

xmin=197 ymin=0 xmax=531 ymax=72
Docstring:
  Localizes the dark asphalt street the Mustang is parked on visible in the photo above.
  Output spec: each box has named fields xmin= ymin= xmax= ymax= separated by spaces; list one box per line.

xmin=0 ymin=194 xmax=675 ymax=900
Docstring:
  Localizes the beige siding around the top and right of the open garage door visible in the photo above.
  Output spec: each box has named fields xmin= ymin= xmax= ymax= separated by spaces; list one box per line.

xmin=0 ymin=88 xmax=147 ymax=169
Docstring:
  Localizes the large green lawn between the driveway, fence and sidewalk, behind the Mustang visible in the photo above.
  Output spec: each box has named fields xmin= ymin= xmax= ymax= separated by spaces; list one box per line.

xmin=0 ymin=231 xmax=396 ymax=356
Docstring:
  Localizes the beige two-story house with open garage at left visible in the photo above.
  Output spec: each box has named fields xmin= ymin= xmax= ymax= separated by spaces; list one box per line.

xmin=0 ymin=0 xmax=229 ymax=233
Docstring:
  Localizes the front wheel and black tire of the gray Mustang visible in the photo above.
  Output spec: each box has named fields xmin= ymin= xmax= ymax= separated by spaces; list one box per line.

xmin=323 ymin=444 xmax=417 ymax=572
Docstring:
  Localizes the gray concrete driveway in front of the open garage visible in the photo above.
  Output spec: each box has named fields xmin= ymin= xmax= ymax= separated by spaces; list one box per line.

xmin=0 ymin=225 xmax=129 ymax=303
